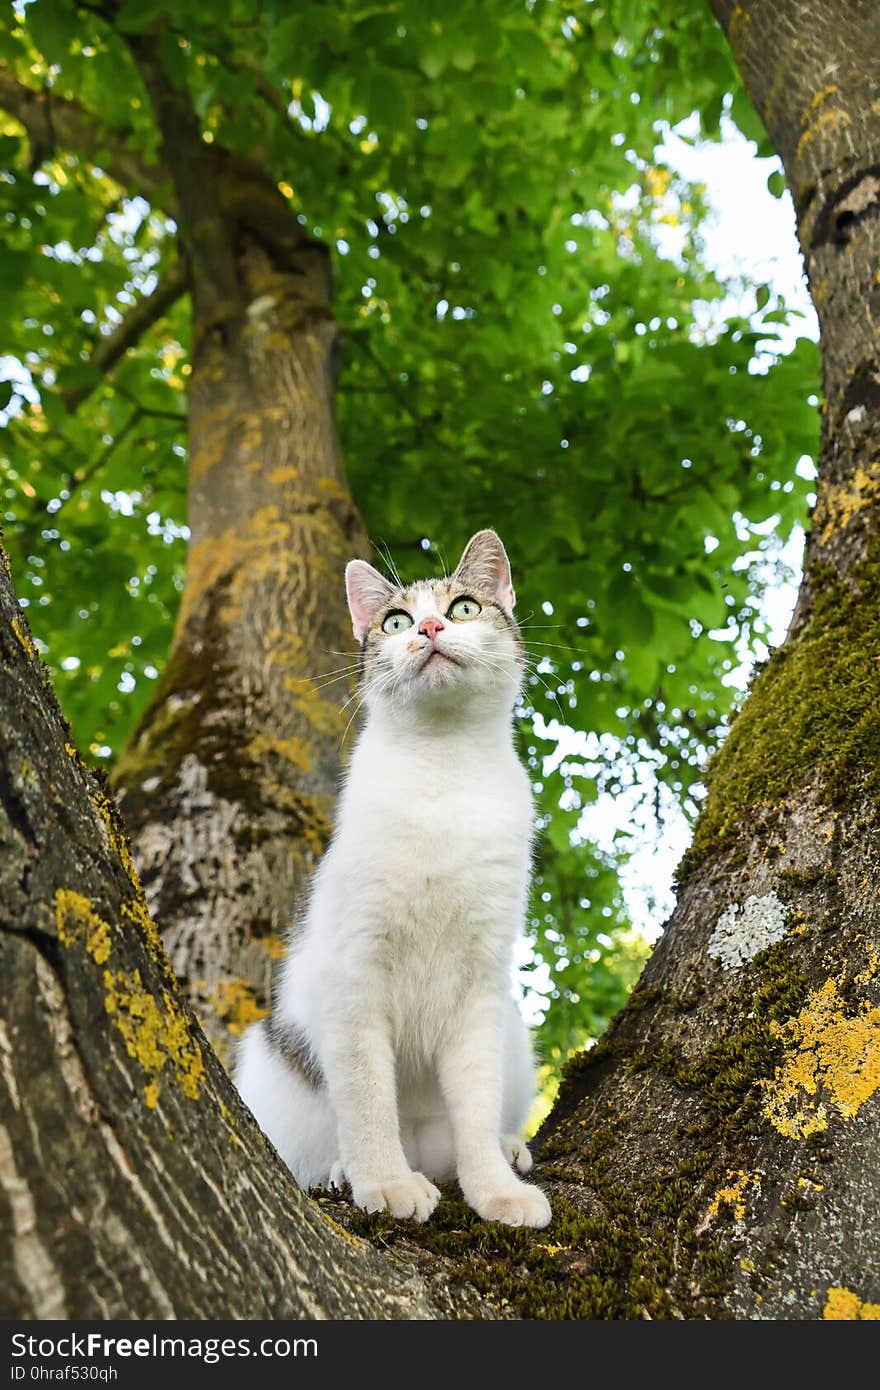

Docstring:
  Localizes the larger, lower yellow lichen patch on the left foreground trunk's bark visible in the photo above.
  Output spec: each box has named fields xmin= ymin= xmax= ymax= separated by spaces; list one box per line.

xmin=104 ymin=970 xmax=204 ymax=1101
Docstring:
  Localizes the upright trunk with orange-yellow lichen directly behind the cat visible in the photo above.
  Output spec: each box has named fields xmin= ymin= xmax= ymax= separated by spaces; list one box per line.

xmin=114 ymin=38 xmax=368 ymax=1056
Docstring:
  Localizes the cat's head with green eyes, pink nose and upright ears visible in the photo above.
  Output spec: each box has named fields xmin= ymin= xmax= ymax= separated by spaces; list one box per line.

xmin=345 ymin=531 xmax=523 ymax=710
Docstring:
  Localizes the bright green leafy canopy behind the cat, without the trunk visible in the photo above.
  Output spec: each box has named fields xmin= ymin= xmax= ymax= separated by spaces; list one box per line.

xmin=0 ymin=0 xmax=817 ymax=1055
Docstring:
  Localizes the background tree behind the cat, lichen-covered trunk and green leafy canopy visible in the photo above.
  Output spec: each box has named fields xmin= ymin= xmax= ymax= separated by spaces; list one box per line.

xmin=0 ymin=0 xmax=815 ymax=1061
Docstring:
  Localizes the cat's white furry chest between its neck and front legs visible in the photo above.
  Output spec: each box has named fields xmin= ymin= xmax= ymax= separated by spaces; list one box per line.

xmin=338 ymin=746 xmax=531 ymax=1036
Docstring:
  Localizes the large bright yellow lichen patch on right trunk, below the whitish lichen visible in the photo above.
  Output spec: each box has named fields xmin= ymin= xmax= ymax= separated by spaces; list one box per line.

xmin=760 ymin=980 xmax=880 ymax=1138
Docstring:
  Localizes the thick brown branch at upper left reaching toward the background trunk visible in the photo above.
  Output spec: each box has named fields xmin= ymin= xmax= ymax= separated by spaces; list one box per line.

xmin=0 ymin=65 xmax=175 ymax=207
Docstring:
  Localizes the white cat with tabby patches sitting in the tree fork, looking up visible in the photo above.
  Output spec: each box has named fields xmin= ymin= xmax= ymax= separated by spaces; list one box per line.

xmin=236 ymin=531 xmax=551 ymax=1226
